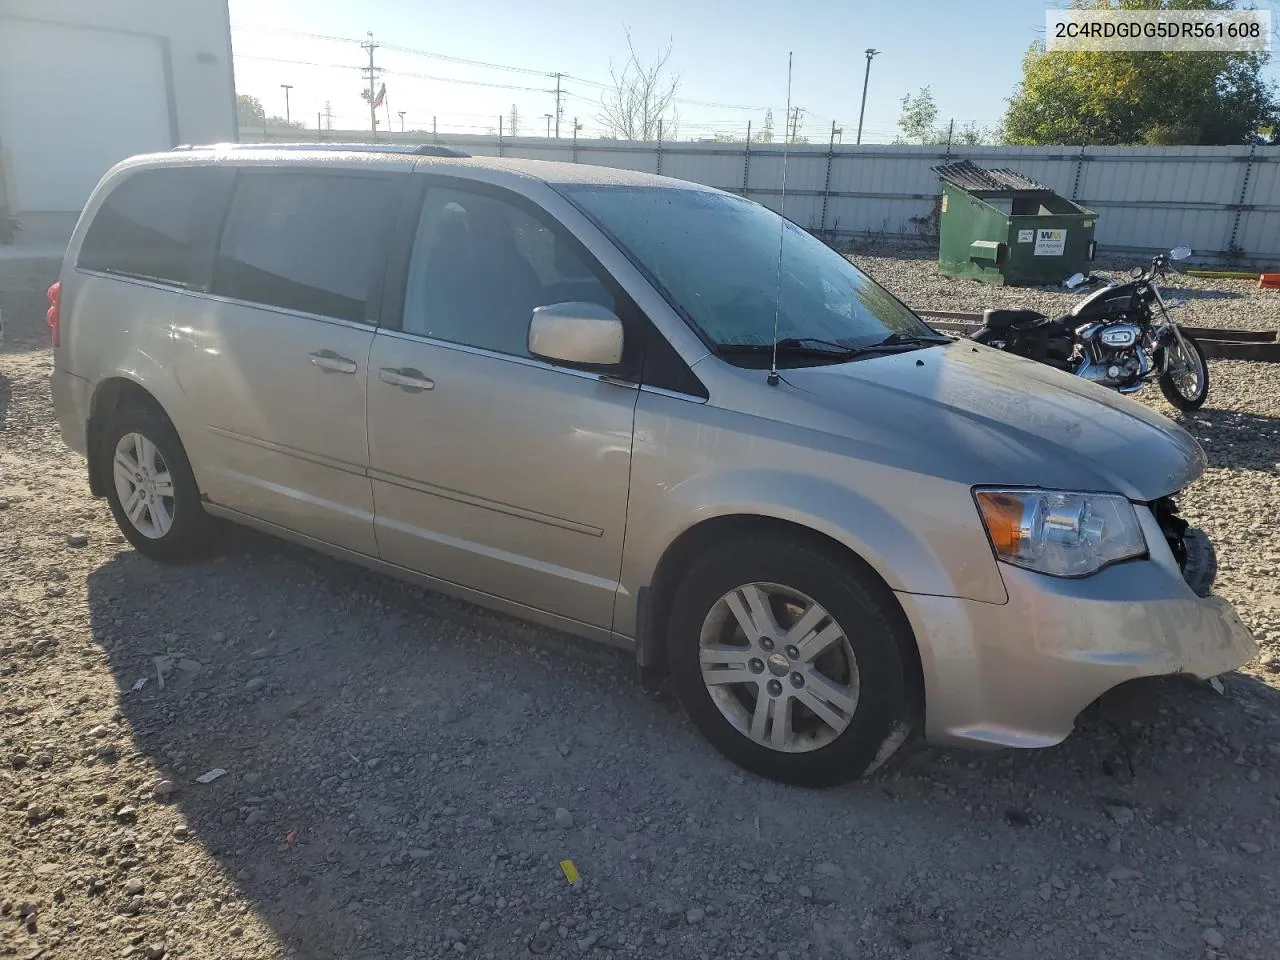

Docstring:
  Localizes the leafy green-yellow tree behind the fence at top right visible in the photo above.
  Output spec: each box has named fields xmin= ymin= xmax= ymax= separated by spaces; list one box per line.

xmin=1004 ymin=0 xmax=1280 ymax=146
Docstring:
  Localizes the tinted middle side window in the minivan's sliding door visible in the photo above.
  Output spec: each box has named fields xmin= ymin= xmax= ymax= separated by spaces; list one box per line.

xmin=214 ymin=170 xmax=396 ymax=320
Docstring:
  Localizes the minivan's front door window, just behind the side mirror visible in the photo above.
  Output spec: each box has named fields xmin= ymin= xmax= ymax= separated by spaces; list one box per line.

xmin=403 ymin=187 xmax=617 ymax=356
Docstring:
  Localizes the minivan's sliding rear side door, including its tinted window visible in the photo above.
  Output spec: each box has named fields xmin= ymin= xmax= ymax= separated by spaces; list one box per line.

xmin=174 ymin=168 xmax=403 ymax=556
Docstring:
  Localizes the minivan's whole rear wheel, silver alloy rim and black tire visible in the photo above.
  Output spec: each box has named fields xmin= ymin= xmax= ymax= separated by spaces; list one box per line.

xmin=100 ymin=407 xmax=215 ymax=563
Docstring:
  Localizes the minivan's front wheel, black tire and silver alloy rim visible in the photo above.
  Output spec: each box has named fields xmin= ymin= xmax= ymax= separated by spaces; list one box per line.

xmin=668 ymin=538 xmax=911 ymax=786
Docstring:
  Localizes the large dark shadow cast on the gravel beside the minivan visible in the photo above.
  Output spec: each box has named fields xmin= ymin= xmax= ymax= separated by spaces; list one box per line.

xmin=88 ymin=531 xmax=1280 ymax=960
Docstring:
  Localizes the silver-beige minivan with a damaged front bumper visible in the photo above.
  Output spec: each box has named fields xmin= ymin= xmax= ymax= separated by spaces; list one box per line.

xmin=49 ymin=146 xmax=1256 ymax=785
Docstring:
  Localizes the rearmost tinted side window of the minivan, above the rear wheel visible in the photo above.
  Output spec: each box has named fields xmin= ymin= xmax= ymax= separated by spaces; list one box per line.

xmin=77 ymin=166 xmax=233 ymax=291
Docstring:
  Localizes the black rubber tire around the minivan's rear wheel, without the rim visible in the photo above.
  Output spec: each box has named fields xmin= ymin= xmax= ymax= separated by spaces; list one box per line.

xmin=99 ymin=406 xmax=218 ymax=563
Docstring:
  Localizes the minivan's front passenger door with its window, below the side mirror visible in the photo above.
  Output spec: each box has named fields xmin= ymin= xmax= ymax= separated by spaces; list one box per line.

xmin=369 ymin=186 xmax=639 ymax=628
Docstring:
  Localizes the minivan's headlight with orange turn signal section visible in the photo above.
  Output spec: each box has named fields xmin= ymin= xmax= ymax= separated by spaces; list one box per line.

xmin=974 ymin=490 xmax=1147 ymax=577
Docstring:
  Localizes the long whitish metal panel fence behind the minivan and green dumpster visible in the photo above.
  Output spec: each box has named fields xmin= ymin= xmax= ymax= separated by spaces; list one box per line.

xmin=241 ymin=131 xmax=1280 ymax=265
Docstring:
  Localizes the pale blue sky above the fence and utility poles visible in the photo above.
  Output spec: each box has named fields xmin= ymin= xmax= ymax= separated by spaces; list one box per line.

xmin=229 ymin=0 xmax=1280 ymax=143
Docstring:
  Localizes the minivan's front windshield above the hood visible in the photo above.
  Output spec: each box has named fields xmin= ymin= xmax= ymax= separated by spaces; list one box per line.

xmin=559 ymin=184 xmax=945 ymax=366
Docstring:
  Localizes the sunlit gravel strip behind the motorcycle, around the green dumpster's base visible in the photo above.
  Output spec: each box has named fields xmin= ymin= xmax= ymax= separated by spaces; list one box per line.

xmin=852 ymin=246 xmax=1280 ymax=330
